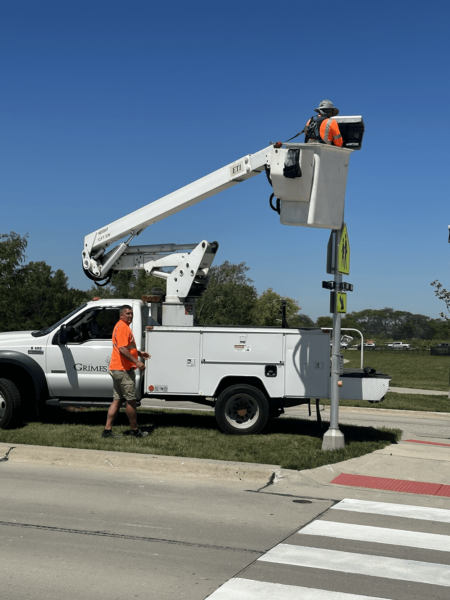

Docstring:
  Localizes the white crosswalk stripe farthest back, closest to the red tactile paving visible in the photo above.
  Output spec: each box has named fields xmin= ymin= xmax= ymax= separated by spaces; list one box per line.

xmin=331 ymin=498 xmax=450 ymax=523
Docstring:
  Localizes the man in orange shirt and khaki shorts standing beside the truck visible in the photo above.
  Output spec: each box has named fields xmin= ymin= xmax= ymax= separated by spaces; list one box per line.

xmin=102 ymin=304 xmax=150 ymax=438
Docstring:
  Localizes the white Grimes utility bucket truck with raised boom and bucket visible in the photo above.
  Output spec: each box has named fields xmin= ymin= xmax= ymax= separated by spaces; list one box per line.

xmin=0 ymin=117 xmax=390 ymax=434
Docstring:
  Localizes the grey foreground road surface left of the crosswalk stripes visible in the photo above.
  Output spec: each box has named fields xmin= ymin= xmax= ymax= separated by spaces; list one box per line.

xmin=0 ymin=461 xmax=332 ymax=600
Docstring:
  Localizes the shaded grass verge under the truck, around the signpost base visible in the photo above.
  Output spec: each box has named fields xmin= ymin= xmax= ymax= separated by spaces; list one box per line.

xmin=0 ymin=409 xmax=401 ymax=470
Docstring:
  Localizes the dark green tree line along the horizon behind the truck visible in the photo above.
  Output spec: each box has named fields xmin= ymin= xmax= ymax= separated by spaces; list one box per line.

xmin=0 ymin=232 xmax=450 ymax=343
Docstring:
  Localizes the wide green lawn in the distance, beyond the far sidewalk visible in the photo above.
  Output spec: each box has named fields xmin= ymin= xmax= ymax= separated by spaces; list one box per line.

xmin=343 ymin=350 xmax=450 ymax=392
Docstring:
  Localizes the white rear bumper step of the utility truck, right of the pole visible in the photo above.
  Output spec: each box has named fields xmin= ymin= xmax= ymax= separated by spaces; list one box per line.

xmin=339 ymin=369 xmax=392 ymax=402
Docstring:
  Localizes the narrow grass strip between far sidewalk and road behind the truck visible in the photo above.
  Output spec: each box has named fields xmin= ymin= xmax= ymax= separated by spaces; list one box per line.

xmin=321 ymin=392 xmax=450 ymax=413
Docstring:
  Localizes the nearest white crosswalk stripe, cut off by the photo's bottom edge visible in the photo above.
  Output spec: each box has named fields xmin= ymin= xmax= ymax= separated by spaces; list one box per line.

xmin=208 ymin=578 xmax=390 ymax=600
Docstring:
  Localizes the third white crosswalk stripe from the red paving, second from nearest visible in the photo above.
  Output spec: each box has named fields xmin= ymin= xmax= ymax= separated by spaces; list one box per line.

xmin=258 ymin=544 xmax=450 ymax=587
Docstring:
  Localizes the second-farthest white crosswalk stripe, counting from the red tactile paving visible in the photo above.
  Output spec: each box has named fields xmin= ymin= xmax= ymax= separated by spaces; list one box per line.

xmin=298 ymin=521 xmax=450 ymax=552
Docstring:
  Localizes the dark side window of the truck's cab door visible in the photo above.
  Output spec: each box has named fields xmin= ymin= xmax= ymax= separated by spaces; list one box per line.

xmin=67 ymin=307 xmax=119 ymax=344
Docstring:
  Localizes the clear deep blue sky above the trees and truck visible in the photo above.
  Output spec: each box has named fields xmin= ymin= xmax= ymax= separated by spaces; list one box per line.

xmin=0 ymin=0 xmax=450 ymax=318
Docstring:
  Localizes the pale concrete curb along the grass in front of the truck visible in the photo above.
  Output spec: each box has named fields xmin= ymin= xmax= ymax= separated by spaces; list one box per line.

xmin=0 ymin=443 xmax=281 ymax=485
